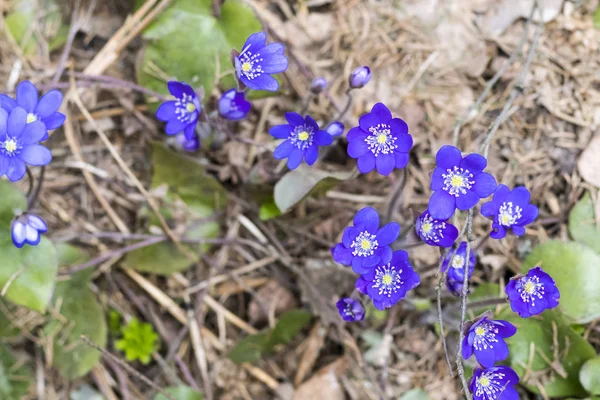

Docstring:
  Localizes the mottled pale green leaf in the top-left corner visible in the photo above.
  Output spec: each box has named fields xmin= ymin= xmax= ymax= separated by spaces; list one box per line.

xmin=4 ymin=0 xmax=69 ymax=54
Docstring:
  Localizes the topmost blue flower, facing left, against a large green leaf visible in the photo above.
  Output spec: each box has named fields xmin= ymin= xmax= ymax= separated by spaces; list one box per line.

xmin=234 ymin=32 xmax=288 ymax=92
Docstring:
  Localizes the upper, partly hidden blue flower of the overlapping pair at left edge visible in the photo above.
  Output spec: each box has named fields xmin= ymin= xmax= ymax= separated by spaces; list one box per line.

xmin=0 ymin=81 xmax=66 ymax=142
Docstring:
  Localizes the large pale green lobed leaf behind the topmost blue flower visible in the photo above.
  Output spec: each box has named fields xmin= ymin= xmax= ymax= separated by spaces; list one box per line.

xmin=136 ymin=0 xmax=261 ymax=104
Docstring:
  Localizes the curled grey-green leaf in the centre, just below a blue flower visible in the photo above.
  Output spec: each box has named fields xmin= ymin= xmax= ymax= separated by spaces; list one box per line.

xmin=273 ymin=164 xmax=358 ymax=213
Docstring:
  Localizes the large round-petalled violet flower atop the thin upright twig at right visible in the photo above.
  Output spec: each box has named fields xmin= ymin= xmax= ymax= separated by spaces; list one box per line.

xmin=429 ymin=146 xmax=496 ymax=220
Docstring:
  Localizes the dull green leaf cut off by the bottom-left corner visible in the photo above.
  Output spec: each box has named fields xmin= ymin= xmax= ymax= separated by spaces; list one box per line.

xmin=0 ymin=345 xmax=33 ymax=400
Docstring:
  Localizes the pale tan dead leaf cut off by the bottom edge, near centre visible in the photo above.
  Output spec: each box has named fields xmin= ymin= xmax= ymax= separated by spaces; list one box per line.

xmin=292 ymin=357 xmax=348 ymax=400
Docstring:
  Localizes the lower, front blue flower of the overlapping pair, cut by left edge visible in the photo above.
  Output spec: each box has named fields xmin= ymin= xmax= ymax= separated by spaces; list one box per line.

xmin=0 ymin=107 xmax=52 ymax=182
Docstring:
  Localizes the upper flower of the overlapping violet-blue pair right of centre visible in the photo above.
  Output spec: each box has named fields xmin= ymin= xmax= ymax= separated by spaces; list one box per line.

xmin=331 ymin=207 xmax=400 ymax=274
